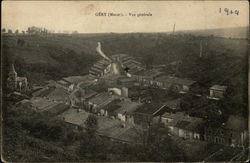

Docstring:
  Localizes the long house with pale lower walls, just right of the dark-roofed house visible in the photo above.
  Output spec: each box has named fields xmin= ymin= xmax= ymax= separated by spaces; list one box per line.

xmin=161 ymin=112 xmax=204 ymax=140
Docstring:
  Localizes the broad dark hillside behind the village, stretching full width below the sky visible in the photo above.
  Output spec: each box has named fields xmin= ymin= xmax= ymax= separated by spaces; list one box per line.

xmin=2 ymin=33 xmax=248 ymax=86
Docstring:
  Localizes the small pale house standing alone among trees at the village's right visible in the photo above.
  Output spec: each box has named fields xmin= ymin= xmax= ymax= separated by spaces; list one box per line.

xmin=209 ymin=85 xmax=227 ymax=99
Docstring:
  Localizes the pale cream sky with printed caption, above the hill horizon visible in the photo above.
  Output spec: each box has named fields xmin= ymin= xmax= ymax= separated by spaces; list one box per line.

xmin=1 ymin=1 xmax=249 ymax=33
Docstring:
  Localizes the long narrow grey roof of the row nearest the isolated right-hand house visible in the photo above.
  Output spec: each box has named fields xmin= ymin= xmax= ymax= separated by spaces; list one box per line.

xmin=155 ymin=75 xmax=196 ymax=85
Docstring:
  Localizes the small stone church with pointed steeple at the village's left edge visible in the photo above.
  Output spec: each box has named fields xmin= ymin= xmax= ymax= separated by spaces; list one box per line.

xmin=7 ymin=64 xmax=28 ymax=91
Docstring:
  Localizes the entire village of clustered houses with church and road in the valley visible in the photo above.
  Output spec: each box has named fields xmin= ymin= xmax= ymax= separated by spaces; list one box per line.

xmin=5 ymin=42 xmax=248 ymax=161
